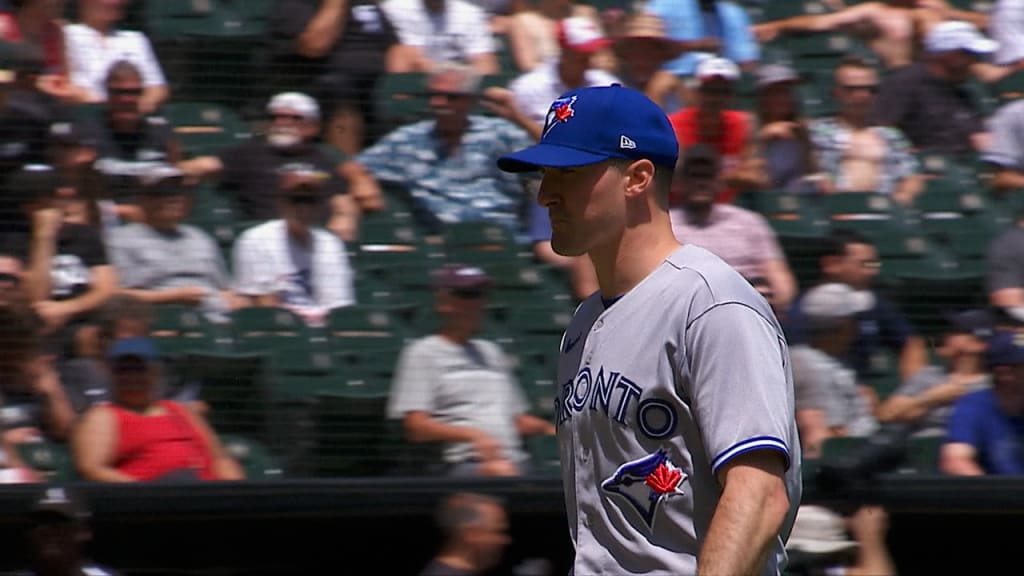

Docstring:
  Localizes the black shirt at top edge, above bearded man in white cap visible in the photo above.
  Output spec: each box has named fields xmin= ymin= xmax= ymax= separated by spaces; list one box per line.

xmin=269 ymin=0 xmax=398 ymax=89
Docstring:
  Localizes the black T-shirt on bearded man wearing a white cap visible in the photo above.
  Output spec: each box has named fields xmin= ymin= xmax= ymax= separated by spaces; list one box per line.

xmin=219 ymin=138 xmax=348 ymax=220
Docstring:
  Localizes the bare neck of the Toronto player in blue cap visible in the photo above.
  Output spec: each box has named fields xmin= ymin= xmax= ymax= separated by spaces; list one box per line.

xmin=590 ymin=222 xmax=680 ymax=298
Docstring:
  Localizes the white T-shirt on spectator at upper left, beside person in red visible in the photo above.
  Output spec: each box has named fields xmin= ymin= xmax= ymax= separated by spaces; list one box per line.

xmin=63 ymin=24 xmax=167 ymax=99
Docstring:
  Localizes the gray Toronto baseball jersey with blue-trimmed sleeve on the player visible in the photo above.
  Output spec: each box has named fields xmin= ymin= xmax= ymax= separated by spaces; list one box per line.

xmin=555 ymin=245 xmax=802 ymax=576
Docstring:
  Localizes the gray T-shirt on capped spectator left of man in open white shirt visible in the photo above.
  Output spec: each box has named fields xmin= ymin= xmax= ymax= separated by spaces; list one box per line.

xmin=110 ymin=223 xmax=230 ymax=320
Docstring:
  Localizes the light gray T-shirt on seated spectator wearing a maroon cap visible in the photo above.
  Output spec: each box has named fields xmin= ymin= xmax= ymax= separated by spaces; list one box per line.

xmin=388 ymin=335 xmax=526 ymax=463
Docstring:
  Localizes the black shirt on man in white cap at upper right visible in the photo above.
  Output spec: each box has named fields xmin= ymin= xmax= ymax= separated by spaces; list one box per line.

xmin=873 ymin=64 xmax=985 ymax=154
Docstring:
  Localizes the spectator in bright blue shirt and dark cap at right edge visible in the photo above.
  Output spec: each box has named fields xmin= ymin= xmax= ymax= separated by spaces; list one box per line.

xmin=939 ymin=331 xmax=1024 ymax=476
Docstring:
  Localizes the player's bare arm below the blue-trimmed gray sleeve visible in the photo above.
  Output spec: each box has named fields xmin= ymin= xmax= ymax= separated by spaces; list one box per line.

xmin=697 ymin=449 xmax=790 ymax=576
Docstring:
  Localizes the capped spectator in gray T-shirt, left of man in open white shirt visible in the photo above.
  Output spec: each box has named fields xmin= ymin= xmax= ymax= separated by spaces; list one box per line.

xmin=110 ymin=168 xmax=233 ymax=323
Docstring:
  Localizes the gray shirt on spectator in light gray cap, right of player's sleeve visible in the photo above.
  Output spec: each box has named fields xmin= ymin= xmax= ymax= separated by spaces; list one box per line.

xmin=790 ymin=344 xmax=879 ymax=437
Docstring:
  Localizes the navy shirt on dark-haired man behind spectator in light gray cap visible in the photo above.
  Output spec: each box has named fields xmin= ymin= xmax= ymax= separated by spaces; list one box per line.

xmin=782 ymin=292 xmax=914 ymax=378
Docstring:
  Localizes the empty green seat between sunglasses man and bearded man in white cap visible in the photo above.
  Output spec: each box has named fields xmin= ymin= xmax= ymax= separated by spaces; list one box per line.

xmin=162 ymin=100 xmax=250 ymax=157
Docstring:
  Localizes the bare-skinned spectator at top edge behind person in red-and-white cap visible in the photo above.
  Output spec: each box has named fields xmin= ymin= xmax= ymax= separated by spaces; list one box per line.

xmin=508 ymin=0 xmax=611 ymax=73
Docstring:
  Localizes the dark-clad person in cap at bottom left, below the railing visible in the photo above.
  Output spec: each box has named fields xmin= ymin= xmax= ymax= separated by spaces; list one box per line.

xmin=17 ymin=486 xmax=117 ymax=576
